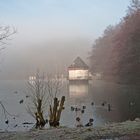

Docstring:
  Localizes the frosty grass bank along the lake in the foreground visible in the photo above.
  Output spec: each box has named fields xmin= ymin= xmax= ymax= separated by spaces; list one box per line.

xmin=0 ymin=118 xmax=140 ymax=140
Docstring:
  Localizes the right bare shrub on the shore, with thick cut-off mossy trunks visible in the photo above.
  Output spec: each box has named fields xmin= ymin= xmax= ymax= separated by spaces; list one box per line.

xmin=47 ymin=75 xmax=65 ymax=127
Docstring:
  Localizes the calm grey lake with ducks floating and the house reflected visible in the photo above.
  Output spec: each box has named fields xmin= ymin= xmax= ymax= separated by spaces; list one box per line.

xmin=0 ymin=80 xmax=140 ymax=131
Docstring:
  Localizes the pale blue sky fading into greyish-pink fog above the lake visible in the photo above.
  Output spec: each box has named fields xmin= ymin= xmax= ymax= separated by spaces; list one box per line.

xmin=0 ymin=0 xmax=130 ymax=79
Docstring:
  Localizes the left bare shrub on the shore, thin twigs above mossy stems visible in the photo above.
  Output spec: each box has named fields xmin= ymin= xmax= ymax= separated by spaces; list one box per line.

xmin=27 ymin=73 xmax=48 ymax=128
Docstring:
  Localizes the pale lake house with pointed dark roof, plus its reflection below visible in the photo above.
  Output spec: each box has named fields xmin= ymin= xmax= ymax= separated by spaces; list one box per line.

xmin=68 ymin=57 xmax=89 ymax=98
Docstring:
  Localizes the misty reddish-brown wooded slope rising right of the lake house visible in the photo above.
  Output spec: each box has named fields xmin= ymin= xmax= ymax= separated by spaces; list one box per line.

xmin=89 ymin=0 xmax=140 ymax=84
